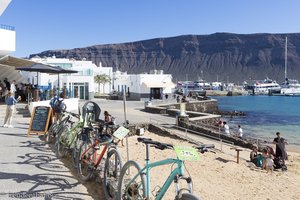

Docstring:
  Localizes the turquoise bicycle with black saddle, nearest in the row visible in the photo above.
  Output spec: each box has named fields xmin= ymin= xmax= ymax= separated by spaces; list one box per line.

xmin=117 ymin=138 xmax=199 ymax=200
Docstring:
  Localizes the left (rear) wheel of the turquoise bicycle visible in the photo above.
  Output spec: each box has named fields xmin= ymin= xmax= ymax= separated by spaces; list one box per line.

xmin=117 ymin=160 xmax=146 ymax=200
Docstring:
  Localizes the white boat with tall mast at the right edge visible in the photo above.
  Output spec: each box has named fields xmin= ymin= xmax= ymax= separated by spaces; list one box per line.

xmin=280 ymin=37 xmax=300 ymax=96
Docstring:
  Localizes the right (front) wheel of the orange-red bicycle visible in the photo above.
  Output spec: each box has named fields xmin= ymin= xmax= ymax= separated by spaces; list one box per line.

xmin=103 ymin=149 xmax=123 ymax=199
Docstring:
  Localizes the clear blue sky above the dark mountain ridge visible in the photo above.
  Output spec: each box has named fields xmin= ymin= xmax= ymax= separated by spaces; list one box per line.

xmin=0 ymin=0 xmax=300 ymax=57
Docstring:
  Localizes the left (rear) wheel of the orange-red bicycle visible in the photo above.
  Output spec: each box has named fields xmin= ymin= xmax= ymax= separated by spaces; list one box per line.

xmin=77 ymin=140 xmax=94 ymax=181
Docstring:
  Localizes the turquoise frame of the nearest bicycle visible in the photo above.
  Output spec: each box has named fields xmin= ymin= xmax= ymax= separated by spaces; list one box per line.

xmin=129 ymin=159 xmax=184 ymax=199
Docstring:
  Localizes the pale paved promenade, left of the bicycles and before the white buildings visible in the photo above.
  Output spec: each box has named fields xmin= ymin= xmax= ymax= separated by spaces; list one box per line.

xmin=0 ymin=99 xmax=175 ymax=200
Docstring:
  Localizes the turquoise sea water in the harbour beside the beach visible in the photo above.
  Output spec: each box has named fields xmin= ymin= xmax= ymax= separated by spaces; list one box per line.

xmin=213 ymin=96 xmax=300 ymax=145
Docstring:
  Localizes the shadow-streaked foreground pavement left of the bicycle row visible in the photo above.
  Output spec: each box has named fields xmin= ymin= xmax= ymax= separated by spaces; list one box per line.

xmin=0 ymin=104 xmax=96 ymax=200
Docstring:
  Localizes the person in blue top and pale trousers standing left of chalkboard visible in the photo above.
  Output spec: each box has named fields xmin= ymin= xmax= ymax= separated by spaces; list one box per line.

xmin=3 ymin=91 xmax=21 ymax=128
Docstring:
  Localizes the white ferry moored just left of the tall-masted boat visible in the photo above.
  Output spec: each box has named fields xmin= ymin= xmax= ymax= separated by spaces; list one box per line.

xmin=253 ymin=78 xmax=281 ymax=95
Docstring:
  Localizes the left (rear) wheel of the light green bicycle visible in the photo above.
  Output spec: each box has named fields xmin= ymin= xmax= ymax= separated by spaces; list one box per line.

xmin=55 ymin=125 xmax=70 ymax=158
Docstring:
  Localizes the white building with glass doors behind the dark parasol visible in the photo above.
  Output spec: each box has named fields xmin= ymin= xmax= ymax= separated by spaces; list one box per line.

xmin=29 ymin=56 xmax=113 ymax=100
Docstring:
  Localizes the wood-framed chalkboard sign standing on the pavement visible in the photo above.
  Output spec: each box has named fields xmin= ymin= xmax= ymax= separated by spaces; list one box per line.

xmin=27 ymin=106 xmax=52 ymax=136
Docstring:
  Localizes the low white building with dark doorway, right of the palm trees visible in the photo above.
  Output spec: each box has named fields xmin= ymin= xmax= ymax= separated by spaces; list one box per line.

xmin=113 ymin=70 xmax=176 ymax=100
